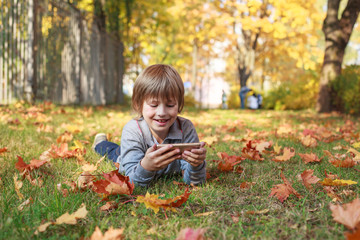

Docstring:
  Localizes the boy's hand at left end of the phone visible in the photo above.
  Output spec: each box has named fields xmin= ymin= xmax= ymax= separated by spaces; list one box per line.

xmin=140 ymin=144 xmax=181 ymax=171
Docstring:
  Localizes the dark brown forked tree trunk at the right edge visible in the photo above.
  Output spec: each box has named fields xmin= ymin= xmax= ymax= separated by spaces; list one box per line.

xmin=316 ymin=0 xmax=360 ymax=113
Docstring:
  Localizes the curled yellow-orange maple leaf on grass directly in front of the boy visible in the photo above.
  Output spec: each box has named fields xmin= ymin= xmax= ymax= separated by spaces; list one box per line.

xmin=136 ymin=188 xmax=191 ymax=213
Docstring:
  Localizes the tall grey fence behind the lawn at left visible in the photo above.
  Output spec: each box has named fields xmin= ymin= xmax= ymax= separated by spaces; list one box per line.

xmin=0 ymin=0 xmax=124 ymax=105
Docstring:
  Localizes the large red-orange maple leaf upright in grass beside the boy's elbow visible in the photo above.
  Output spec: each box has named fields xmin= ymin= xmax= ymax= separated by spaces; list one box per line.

xmin=93 ymin=170 xmax=135 ymax=195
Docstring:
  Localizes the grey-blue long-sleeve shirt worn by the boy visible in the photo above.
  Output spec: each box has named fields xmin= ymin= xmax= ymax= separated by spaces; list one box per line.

xmin=117 ymin=117 xmax=206 ymax=186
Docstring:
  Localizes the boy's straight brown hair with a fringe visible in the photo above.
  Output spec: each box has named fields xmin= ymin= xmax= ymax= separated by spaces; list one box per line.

xmin=131 ymin=64 xmax=184 ymax=116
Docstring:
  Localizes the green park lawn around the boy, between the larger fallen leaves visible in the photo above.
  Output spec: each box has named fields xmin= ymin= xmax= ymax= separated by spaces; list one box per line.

xmin=0 ymin=103 xmax=360 ymax=239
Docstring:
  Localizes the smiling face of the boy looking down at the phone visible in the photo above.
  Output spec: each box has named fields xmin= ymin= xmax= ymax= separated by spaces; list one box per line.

xmin=142 ymin=97 xmax=179 ymax=143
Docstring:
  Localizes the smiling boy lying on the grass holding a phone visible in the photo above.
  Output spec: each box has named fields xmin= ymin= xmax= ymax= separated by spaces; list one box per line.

xmin=93 ymin=64 xmax=206 ymax=186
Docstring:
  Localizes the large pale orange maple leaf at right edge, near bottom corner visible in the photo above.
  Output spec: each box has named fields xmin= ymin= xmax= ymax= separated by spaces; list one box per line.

xmin=330 ymin=198 xmax=360 ymax=230
